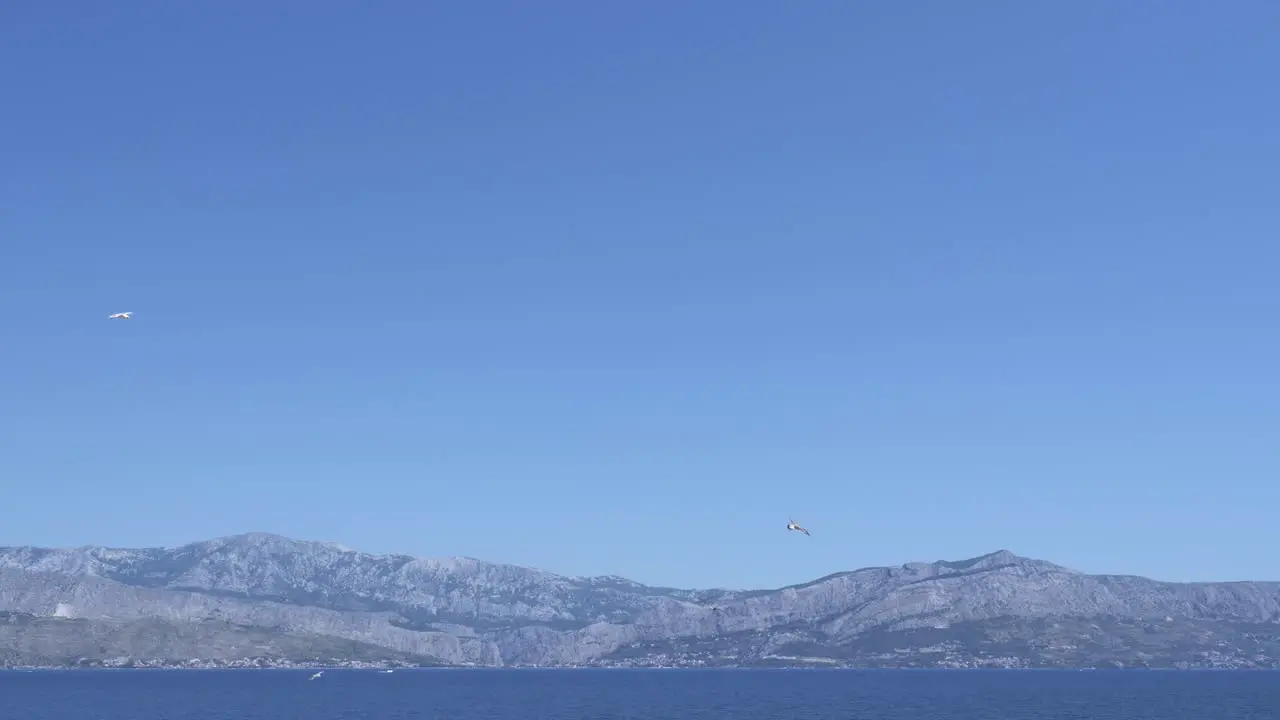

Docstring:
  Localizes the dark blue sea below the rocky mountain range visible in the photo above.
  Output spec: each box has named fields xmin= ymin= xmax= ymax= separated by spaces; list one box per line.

xmin=0 ymin=670 xmax=1280 ymax=720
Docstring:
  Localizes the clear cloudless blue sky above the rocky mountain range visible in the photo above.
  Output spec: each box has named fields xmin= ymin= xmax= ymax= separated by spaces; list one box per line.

xmin=0 ymin=0 xmax=1280 ymax=587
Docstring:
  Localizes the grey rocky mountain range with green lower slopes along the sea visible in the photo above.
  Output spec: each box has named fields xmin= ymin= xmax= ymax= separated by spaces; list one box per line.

xmin=0 ymin=533 xmax=1280 ymax=666
